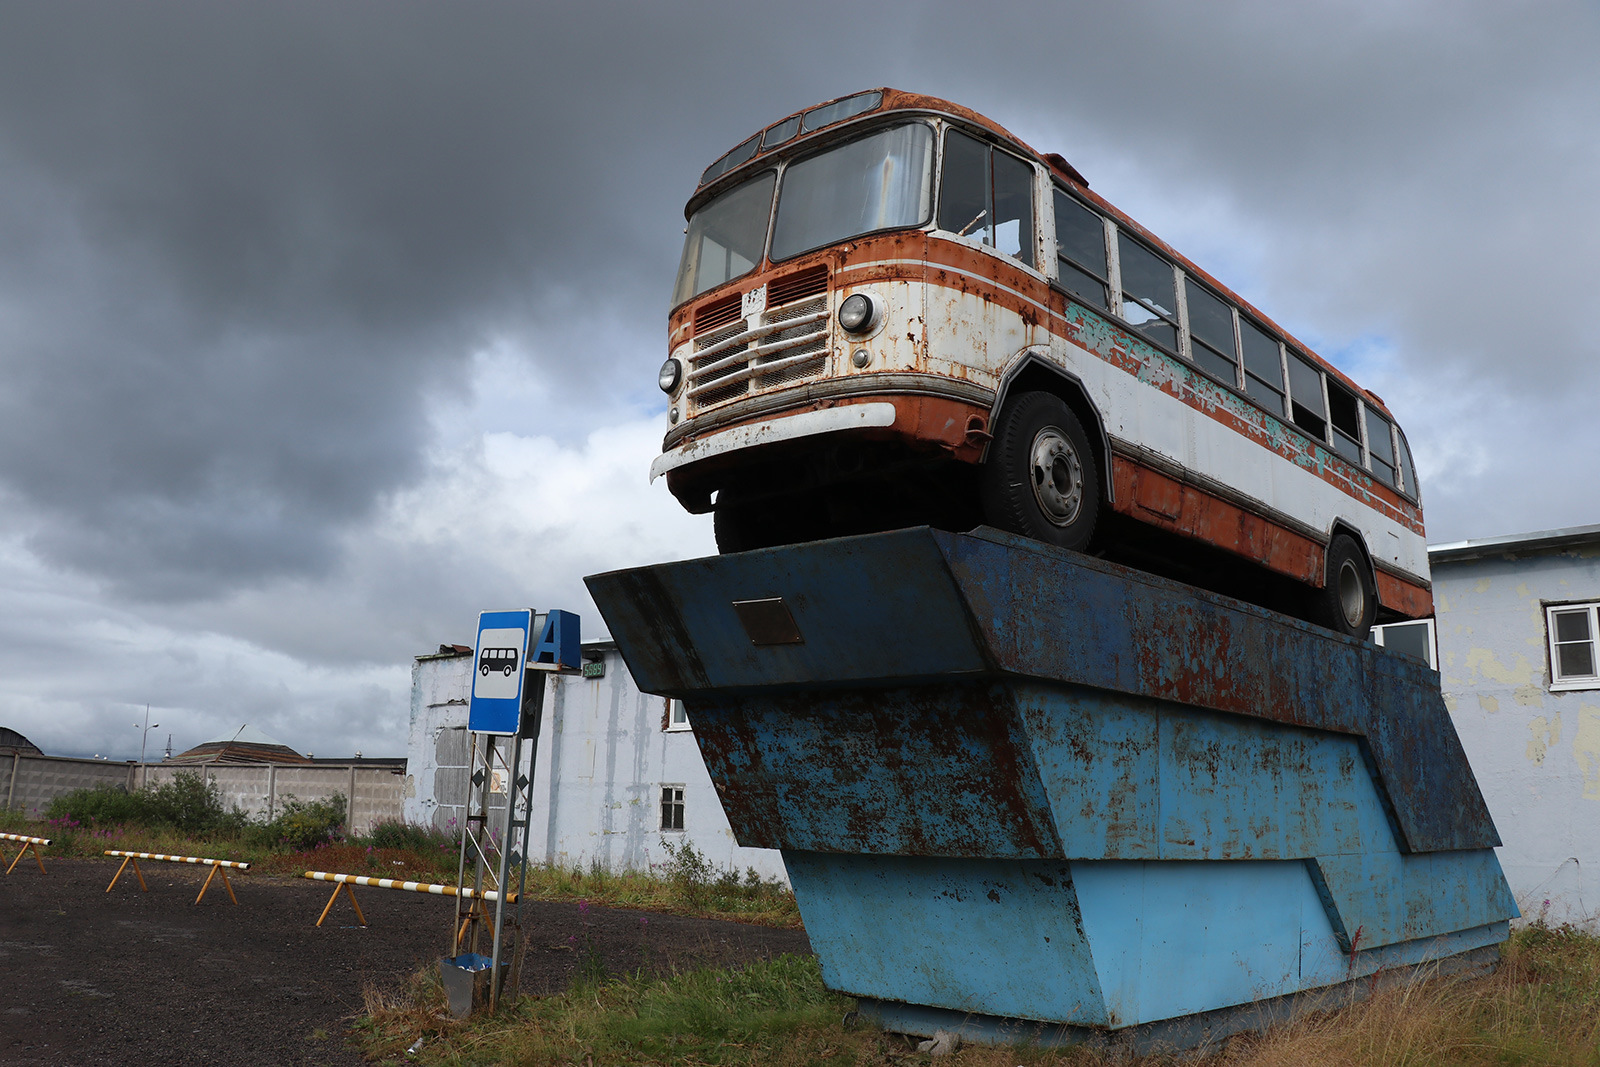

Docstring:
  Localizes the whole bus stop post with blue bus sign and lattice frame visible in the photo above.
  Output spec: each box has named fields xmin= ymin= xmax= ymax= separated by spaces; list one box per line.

xmin=451 ymin=609 xmax=582 ymax=1011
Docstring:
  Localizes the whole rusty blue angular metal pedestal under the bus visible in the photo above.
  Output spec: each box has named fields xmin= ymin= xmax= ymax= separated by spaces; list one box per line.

xmin=587 ymin=530 xmax=1517 ymax=1045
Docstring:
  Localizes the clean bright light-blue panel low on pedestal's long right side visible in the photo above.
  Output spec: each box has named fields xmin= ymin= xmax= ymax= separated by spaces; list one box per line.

xmin=1072 ymin=861 xmax=1338 ymax=1025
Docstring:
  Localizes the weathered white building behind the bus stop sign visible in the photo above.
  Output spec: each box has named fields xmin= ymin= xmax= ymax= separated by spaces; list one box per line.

xmin=405 ymin=641 xmax=787 ymax=880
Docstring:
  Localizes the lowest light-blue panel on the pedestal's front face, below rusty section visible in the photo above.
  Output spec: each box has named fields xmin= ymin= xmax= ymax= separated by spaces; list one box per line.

xmin=784 ymin=849 xmax=1109 ymax=1025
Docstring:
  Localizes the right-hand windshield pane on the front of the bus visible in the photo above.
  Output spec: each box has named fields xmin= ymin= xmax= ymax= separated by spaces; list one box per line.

xmin=771 ymin=122 xmax=933 ymax=261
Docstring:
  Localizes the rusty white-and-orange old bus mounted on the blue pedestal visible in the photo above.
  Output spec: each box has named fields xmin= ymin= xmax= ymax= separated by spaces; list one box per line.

xmin=650 ymin=88 xmax=1432 ymax=638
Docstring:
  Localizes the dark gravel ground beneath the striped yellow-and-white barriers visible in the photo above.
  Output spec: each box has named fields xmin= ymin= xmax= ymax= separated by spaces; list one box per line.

xmin=0 ymin=856 xmax=810 ymax=1067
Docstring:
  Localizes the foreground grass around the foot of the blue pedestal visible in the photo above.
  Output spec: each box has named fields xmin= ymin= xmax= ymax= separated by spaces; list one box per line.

xmin=357 ymin=926 xmax=1600 ymax=1067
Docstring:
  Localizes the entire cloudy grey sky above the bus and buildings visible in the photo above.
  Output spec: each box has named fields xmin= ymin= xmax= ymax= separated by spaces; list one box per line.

xmin=0 ymin=0 xmax=1600 ymax=757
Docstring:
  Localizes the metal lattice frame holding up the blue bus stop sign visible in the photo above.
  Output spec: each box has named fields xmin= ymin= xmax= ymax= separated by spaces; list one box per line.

xmin=451 ymin=670 xmax=549 ymax=1011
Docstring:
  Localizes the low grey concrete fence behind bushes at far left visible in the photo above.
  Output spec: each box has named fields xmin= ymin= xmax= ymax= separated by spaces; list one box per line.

xmin=0 ymin=752 xmax=406 ymax=833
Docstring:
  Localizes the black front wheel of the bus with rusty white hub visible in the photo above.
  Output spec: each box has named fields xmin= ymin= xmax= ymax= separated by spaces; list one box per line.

xmin=981 ymin=392 xmax=1099 ymax=550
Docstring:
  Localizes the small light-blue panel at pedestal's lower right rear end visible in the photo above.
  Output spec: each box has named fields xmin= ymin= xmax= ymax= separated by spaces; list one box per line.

xmin=1317 ymin=848 xmax=1518 ymax=949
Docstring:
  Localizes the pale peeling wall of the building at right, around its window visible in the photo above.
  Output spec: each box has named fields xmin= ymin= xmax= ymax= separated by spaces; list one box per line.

xmin=1432 ymin=545 xmax=1600 ymax=925
